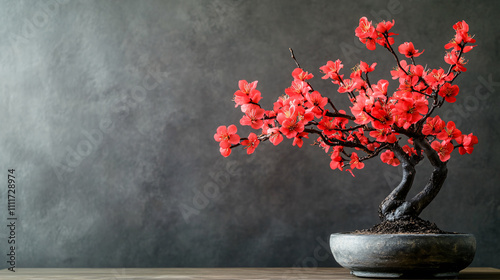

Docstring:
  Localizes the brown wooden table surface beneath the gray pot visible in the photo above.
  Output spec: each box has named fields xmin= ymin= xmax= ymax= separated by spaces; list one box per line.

xmin=0 ymin=267 xmax=500 ymax=280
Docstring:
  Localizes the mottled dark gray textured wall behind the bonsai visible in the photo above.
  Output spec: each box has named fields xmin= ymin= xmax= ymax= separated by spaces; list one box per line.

xmin=0 ymin=0 xmax=500 ymax=272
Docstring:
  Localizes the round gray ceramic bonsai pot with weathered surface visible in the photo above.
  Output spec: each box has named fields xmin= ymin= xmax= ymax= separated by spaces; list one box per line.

xmin=330 ymin=233 xmax=476 ymax=278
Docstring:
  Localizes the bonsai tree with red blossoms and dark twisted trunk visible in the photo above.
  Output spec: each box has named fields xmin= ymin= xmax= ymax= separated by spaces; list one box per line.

xmin=214 ymin=17 xmax=478 ymax=224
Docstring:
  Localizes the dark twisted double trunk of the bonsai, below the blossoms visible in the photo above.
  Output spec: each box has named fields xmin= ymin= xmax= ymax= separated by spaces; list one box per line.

xmin=379 ymin=138 xmax=448 ymax=221
